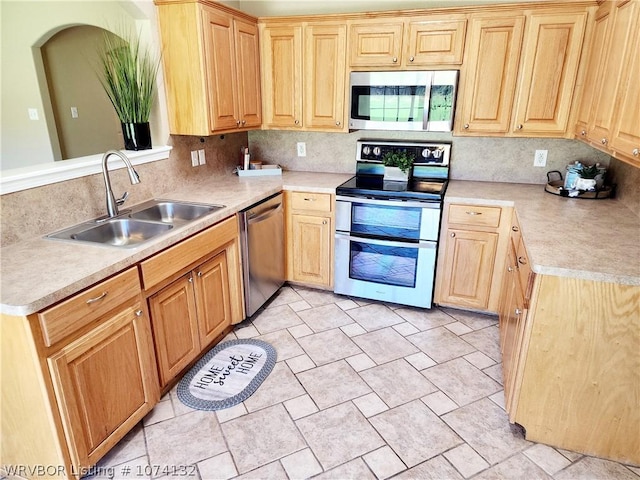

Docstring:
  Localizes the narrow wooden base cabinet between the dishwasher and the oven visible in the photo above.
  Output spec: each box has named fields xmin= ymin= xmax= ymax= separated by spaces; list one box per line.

xmin=285 ymin=192 xmax=334 ymax=289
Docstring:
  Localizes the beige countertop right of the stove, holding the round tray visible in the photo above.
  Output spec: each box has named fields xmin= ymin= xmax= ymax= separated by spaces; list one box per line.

xmin=445 ymin=180 xmax=640 ymax=285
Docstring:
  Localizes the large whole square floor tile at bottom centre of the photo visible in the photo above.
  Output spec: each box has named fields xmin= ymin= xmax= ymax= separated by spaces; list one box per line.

xmin=296 ymin=402 xmax=384 ymax=470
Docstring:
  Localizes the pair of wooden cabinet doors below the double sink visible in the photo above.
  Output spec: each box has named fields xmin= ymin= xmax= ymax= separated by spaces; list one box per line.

xmin=149 ymin=251 xmax=231 ymax=387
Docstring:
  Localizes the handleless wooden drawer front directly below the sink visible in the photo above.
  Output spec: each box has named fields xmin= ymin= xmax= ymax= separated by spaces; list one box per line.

xmin=140 ymin=216 xmax=238 ymax=290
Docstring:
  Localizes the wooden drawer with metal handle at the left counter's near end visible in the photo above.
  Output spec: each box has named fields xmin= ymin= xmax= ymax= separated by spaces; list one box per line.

xmin=38 ymin=268 xmax=141 ymax=347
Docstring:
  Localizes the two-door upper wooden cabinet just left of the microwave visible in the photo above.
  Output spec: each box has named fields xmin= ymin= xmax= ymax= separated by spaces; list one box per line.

xmin=260 ymin=21 xmax=348 ymax=132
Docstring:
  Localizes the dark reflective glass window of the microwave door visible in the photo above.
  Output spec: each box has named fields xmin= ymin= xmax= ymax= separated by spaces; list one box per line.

xmin=351 ymin=86 xmax=426 ymax=122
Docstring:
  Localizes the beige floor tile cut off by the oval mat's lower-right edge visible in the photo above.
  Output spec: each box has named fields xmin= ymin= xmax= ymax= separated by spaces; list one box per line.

xmin=244 ymin=362 xmax=305 ymax=412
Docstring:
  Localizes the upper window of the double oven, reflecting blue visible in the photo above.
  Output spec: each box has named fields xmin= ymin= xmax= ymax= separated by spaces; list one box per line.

xmin=351 ymin=203 xmax=422 ymax=240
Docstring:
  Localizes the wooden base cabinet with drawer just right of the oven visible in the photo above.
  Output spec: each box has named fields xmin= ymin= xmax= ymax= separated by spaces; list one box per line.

xmin=435 ymin=204 xmax=510 ymax=312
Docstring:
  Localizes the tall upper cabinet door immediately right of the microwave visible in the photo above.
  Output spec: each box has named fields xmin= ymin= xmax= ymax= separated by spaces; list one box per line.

xmin=456 ymin=15 xmax=524 ymax=135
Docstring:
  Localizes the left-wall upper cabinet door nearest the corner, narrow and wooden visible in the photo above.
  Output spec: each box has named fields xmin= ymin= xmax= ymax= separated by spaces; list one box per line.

xmin=233 ymin=18 xmax=262 ymax=128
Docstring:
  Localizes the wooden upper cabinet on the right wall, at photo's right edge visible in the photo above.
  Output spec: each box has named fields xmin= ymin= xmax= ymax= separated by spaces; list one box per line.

xmin=575 ymin=0 xmax=640 ymax=165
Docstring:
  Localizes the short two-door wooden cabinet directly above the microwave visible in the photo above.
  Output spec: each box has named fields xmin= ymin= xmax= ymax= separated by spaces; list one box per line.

xmin=349 ymin=14 xmax=467 ymax=68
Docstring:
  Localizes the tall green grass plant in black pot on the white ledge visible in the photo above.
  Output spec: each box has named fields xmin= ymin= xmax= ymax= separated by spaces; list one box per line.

xmin=99 ymin=30 xmax=160 ymax=150
